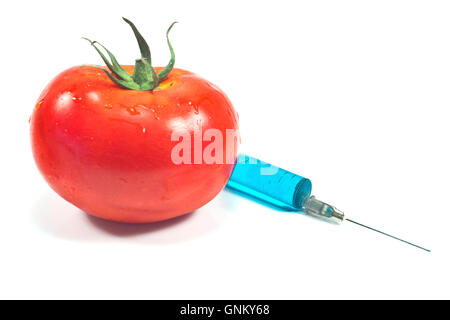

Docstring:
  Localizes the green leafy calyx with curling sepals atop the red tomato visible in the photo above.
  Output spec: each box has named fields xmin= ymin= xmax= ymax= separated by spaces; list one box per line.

xmin=83 ymin=18 xmax=176 ymax=91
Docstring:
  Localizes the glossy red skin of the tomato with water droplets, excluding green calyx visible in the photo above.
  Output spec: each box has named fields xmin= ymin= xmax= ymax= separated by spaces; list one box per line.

xmin=30 ymin=66 xmax=238 ymax=223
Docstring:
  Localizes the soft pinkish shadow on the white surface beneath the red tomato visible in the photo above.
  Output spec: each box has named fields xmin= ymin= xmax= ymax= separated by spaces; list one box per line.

xmin=32 ymin=191 xmax=227 ymax=244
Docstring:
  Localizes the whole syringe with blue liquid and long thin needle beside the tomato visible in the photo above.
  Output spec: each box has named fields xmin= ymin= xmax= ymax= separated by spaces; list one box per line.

xmin=227 ymin=154 xmax=430 ymax=252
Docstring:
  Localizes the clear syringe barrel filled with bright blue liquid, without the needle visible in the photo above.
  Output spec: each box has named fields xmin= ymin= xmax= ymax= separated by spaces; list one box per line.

xmin=227 ymin=154 xmax=312 ymax=210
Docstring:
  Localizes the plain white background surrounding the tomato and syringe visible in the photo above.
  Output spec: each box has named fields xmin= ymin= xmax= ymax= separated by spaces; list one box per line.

xmin=0 ymin=0 xmax=450 ymax=299
